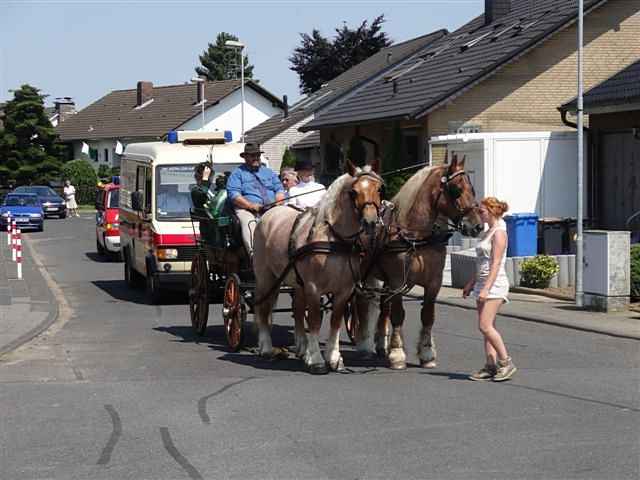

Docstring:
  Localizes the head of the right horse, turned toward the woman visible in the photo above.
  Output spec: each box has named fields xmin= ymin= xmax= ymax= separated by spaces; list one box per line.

xmin=436 ymin=154 xmax=483 ymax=237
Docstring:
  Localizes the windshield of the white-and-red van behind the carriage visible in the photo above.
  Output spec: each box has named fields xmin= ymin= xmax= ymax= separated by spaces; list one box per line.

xmin=156 ymin=165 xmax=195 ymax=220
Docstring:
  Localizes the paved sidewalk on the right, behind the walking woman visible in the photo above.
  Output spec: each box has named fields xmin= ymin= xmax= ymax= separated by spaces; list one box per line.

xmin=432 ymin=287 xmax=640 ymax=340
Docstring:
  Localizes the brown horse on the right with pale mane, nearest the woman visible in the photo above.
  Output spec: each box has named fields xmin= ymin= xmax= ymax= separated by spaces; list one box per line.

xmin=358 ymin=155 xmax=482 ymax=369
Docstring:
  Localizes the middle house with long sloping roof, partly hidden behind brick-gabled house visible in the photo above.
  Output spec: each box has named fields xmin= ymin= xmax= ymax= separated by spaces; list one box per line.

xmin=246 ymin=30 xmax=447 ymax=174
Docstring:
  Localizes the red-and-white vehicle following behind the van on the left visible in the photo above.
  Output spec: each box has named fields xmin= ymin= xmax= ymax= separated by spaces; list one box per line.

xmin=96 ymin=183 xmax=120 ymax=257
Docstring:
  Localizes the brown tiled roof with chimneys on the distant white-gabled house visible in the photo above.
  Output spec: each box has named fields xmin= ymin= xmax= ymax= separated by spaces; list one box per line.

xmin=56 ymin=80 xmax=283 ymax=141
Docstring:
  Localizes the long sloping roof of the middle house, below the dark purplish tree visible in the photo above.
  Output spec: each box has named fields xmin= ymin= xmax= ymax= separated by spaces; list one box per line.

xmin=245 ymin=30 xmax=446 ymax=143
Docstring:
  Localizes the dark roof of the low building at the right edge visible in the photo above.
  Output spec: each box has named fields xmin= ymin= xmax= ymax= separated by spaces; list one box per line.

xmin=560 ymin=60 xmax=640 ymax=113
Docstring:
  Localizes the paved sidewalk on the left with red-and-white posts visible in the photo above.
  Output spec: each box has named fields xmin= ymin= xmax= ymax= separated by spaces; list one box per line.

xmin=0 ymin=232 xmax=58 ymax=357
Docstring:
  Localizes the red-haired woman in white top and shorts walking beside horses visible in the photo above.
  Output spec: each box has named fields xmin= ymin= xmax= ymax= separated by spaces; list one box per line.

xmin=462 ymin=197 xmax=517 ymax=382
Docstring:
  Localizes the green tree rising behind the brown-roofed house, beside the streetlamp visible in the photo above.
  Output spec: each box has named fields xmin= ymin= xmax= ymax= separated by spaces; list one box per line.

xmin=196 ymin=32 xmax=253 ymax=81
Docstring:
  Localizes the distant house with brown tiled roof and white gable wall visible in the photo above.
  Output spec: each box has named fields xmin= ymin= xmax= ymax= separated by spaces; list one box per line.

xmin=56 ymin=80 xmax=284 ymax=169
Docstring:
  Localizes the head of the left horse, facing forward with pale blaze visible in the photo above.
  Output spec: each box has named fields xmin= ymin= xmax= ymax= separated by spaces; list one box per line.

xmin=347 ymin=160 xmax=384 ymax=236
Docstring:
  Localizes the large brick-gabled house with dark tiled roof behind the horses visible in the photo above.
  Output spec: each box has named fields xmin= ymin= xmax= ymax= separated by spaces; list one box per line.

xmin=302 ymin=0 xmax=640 ymax=218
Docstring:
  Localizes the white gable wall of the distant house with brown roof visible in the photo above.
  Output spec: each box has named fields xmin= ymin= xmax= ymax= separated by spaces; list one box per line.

xmin=177 ymin=87 xmax=282 ymax=142
